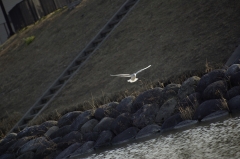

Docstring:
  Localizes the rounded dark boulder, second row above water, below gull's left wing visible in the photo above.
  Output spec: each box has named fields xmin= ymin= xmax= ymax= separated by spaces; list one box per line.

xmin=110 ymin=113 xmax=132 ymax=134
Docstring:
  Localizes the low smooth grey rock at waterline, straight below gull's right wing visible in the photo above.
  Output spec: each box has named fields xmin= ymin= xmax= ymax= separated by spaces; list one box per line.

xmin=136 ymin=124 xmax=161 ymax=139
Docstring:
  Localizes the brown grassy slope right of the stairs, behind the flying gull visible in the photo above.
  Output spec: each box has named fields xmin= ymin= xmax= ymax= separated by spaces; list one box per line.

xmin=42 ymin=0 xmax=240 ymax=115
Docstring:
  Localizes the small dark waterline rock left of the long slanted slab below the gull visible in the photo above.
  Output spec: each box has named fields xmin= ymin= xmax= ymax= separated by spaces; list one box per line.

xmin=94 ymin=130 xmax=114 ymax=148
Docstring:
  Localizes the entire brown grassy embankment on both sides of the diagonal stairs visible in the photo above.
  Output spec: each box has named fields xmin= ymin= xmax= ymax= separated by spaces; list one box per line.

xmin=0 ymin=0 xmax=240 ymax=137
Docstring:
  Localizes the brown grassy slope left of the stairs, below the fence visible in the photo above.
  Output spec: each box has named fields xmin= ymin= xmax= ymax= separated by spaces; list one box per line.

xmin=0 ymin=0 xmax=125 ymax=135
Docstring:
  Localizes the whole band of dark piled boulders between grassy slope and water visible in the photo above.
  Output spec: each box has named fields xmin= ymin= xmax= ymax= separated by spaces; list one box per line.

xmin=0 ymin=64 xmax=240 ymax=159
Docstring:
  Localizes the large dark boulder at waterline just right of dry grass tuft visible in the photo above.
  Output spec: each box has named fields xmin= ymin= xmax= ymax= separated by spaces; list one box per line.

xmin=193 ymin=99 xmax=228 ymax=121
